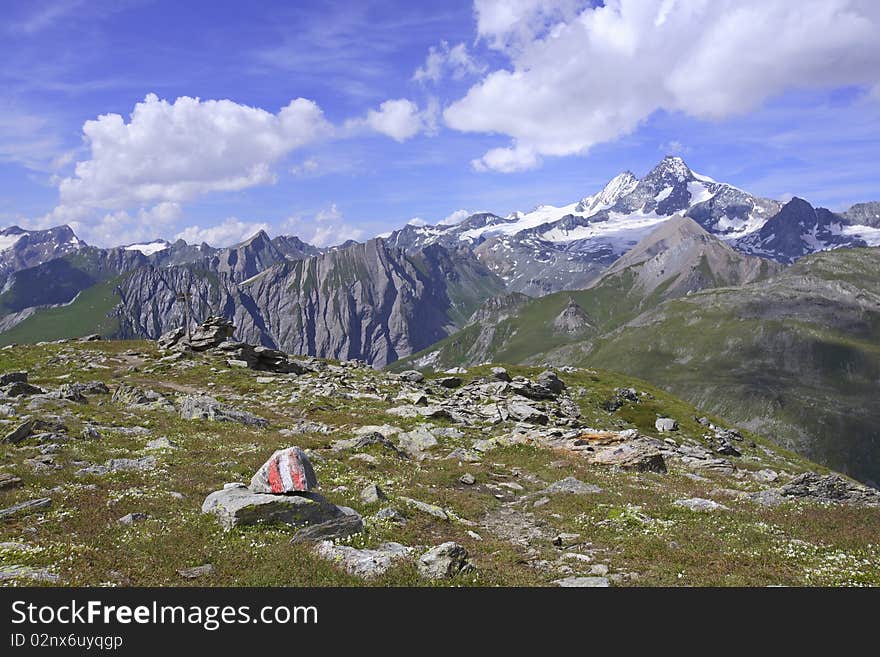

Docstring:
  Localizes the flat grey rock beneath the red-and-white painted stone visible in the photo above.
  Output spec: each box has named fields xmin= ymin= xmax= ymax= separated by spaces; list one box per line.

xmin=202 ymin=484 xmax=343 ymax=529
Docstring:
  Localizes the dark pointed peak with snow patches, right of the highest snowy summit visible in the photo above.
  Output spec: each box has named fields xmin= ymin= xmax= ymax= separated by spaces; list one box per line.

xmin=737 ymin=197 xmax=867 ymax=262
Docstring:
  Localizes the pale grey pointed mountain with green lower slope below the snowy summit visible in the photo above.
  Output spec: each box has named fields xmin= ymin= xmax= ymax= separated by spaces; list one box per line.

xmin=395 ymin=217 xmax=781 ymax=369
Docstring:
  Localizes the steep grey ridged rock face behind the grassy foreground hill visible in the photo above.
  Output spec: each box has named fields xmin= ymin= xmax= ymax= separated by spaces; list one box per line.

xmin=116 ymin=240 xmax=502 ymax=367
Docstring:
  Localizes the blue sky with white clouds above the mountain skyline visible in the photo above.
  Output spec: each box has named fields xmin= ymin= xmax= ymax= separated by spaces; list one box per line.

xmin=0 ymin=0 xmax=880 ymax=245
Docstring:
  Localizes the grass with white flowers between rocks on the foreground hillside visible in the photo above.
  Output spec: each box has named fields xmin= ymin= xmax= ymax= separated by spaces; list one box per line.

xmin=0 ymin=341 xmax=880 ymax=586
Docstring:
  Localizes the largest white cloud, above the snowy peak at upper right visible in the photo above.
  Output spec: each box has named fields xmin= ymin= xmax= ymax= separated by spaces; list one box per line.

xmin=444 ymin=0 xmax=880 ymax=171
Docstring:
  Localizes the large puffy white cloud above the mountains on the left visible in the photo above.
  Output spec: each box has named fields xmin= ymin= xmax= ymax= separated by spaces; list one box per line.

xmin=59 ymin=94 xmax=330 ymax=208
